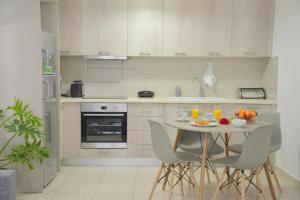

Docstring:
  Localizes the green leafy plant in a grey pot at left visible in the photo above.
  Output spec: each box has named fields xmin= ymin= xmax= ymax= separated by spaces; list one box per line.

xmin=0 ymin=99 xmax=49 ymax=200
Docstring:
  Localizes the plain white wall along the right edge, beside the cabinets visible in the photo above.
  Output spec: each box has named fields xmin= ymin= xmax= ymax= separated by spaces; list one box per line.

xmin=273 ymin=0 xmax=300 ymax=181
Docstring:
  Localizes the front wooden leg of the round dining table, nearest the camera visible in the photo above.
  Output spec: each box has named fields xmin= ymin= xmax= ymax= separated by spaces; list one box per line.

xmin=199 ymin=133 xmax=208 ymax=200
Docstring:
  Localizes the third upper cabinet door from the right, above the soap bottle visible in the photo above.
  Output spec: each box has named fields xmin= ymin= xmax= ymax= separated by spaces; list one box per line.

xmin=164 ymin=0 xmax=197 ymax=56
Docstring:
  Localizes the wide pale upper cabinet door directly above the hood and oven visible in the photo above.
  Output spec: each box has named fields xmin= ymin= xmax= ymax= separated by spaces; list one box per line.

xmin=82 ymin=0 xmax=127 ymax=56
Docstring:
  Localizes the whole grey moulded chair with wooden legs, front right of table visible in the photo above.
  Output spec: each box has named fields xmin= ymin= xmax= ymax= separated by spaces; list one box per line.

xmin=212 ymin=125 xmax=272 ymax=200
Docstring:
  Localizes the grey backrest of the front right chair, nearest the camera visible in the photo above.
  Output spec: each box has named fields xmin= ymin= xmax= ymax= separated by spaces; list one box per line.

xmin=232 ymin=125 xmax=272 ymax=169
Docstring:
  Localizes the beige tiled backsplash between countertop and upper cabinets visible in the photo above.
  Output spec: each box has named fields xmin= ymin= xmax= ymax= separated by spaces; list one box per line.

xmin=61 ymin=57 xmax=277 ymax=98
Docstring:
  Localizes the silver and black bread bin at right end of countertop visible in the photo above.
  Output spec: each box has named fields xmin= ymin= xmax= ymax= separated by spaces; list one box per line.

xmin=237 ymin=88 xmax=266 ymax=99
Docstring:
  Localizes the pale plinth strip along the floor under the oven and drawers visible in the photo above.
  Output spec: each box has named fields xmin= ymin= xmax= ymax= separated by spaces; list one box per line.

xmin=61 ymin=158 xmax=161 ymax=166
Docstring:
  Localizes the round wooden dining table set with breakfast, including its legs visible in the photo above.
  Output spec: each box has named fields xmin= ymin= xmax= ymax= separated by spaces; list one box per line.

xmin=166 ymin=119 xmax=276 ymax=200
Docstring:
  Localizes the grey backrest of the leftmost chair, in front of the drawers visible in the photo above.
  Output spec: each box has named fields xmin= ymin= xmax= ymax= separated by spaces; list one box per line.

xmin=148 ymin=120 xmax=178 ymax=162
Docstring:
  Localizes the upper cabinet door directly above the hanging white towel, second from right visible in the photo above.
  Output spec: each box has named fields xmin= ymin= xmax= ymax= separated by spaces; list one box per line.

xmin=197 ymin=0 xmax=233 ymax=56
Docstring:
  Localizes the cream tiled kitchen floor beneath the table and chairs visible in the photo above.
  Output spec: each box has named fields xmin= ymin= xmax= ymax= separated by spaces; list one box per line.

xmin=17 ymin=166 xmax=300 ymax=200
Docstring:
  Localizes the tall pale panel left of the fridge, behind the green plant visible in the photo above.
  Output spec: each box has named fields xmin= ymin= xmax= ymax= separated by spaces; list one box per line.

xmin=0 ymin=0 xmax=43 ymax=192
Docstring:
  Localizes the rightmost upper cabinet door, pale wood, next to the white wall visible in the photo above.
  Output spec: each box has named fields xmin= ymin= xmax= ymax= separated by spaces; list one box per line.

xmin=232 ymin=0 xmax=271 ymax=56
